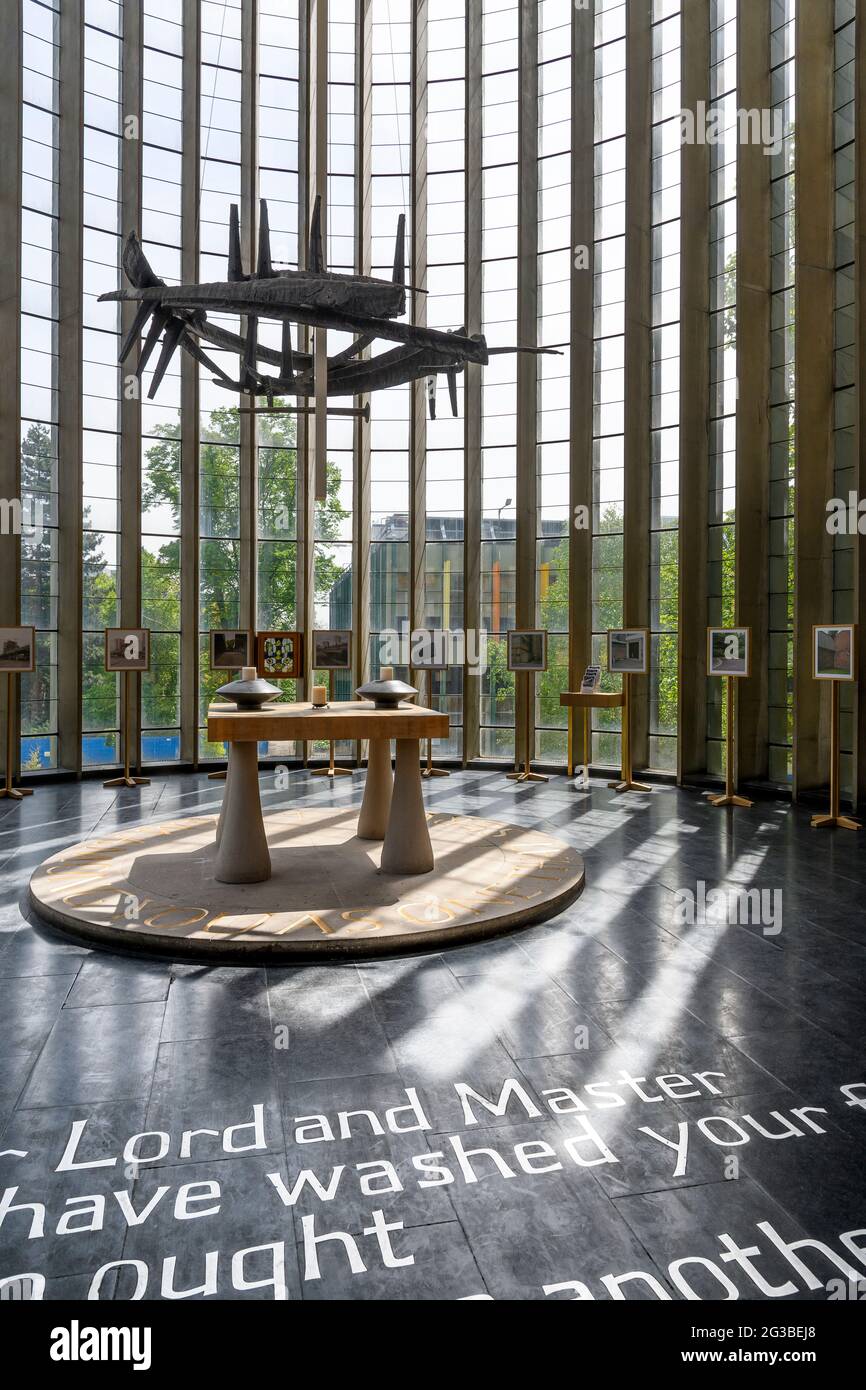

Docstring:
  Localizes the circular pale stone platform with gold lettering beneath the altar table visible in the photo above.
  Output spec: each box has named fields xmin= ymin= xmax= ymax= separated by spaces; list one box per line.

xmin=31 ymin=808 xmax=584 ymax=962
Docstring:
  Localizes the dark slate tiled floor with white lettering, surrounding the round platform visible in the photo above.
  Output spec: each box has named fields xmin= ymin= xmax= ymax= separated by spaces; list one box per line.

xmin=0 ymin=773 xmax=866 ymax=1300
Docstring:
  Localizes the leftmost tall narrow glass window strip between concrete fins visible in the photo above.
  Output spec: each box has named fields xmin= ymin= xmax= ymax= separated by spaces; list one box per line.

xmin=19 ymin=0 xmax=61 ymax=771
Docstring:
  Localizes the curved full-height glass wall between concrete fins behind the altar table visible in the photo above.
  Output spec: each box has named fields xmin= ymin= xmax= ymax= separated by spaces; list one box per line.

xmin=6 ymin=0 xmax=859 ymax=790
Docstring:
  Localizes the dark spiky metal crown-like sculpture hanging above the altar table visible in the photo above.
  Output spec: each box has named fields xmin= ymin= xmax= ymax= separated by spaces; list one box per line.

xmin=100 ymin=199 xmax=549 ymax=420
